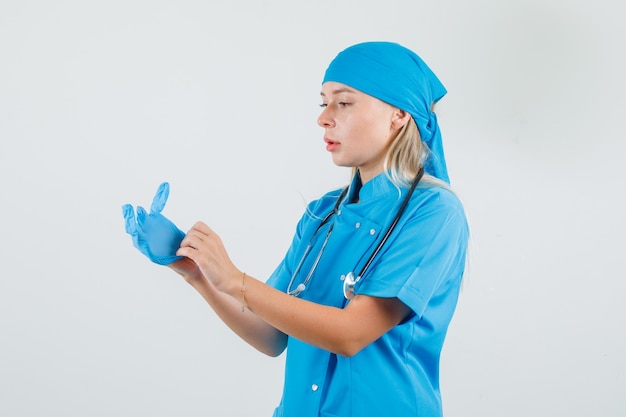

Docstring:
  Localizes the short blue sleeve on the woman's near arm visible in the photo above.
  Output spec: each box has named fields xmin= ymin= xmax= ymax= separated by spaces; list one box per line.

xmin=356 ymin=191 xmax=469 ymax=318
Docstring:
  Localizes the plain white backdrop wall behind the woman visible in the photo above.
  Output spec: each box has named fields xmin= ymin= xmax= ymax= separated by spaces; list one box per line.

xmin=0 ymin=0 xmax=626 ymax=417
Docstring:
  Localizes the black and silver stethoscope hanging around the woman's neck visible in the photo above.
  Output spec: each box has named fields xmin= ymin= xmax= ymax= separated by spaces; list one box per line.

xmin=287 ymin=167 xmax=424 ymax=300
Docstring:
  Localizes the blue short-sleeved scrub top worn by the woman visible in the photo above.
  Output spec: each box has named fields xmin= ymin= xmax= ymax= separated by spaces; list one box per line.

xmin=267 ymin=173 xmax=469 ymax=417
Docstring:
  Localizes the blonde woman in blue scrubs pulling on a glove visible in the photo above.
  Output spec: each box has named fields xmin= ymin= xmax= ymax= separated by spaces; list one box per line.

xmin=124 ymin=42 xmax=468 ymax=417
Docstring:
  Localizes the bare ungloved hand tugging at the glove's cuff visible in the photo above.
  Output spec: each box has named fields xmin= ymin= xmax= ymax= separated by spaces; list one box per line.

xmin=176 ymin=222 xmax=241 ymax=292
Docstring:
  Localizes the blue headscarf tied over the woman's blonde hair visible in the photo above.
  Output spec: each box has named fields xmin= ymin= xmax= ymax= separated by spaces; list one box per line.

xmin=322 ymin=42 xmax=450 ymax=183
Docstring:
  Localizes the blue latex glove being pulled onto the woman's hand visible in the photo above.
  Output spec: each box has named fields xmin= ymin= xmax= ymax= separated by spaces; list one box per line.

xmin=122 ymin=182 xmax=185 ymax=265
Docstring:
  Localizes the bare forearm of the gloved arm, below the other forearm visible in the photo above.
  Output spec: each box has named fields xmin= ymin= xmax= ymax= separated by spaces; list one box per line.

xmin=170 ymin=259 xmax=287 ymax=356
